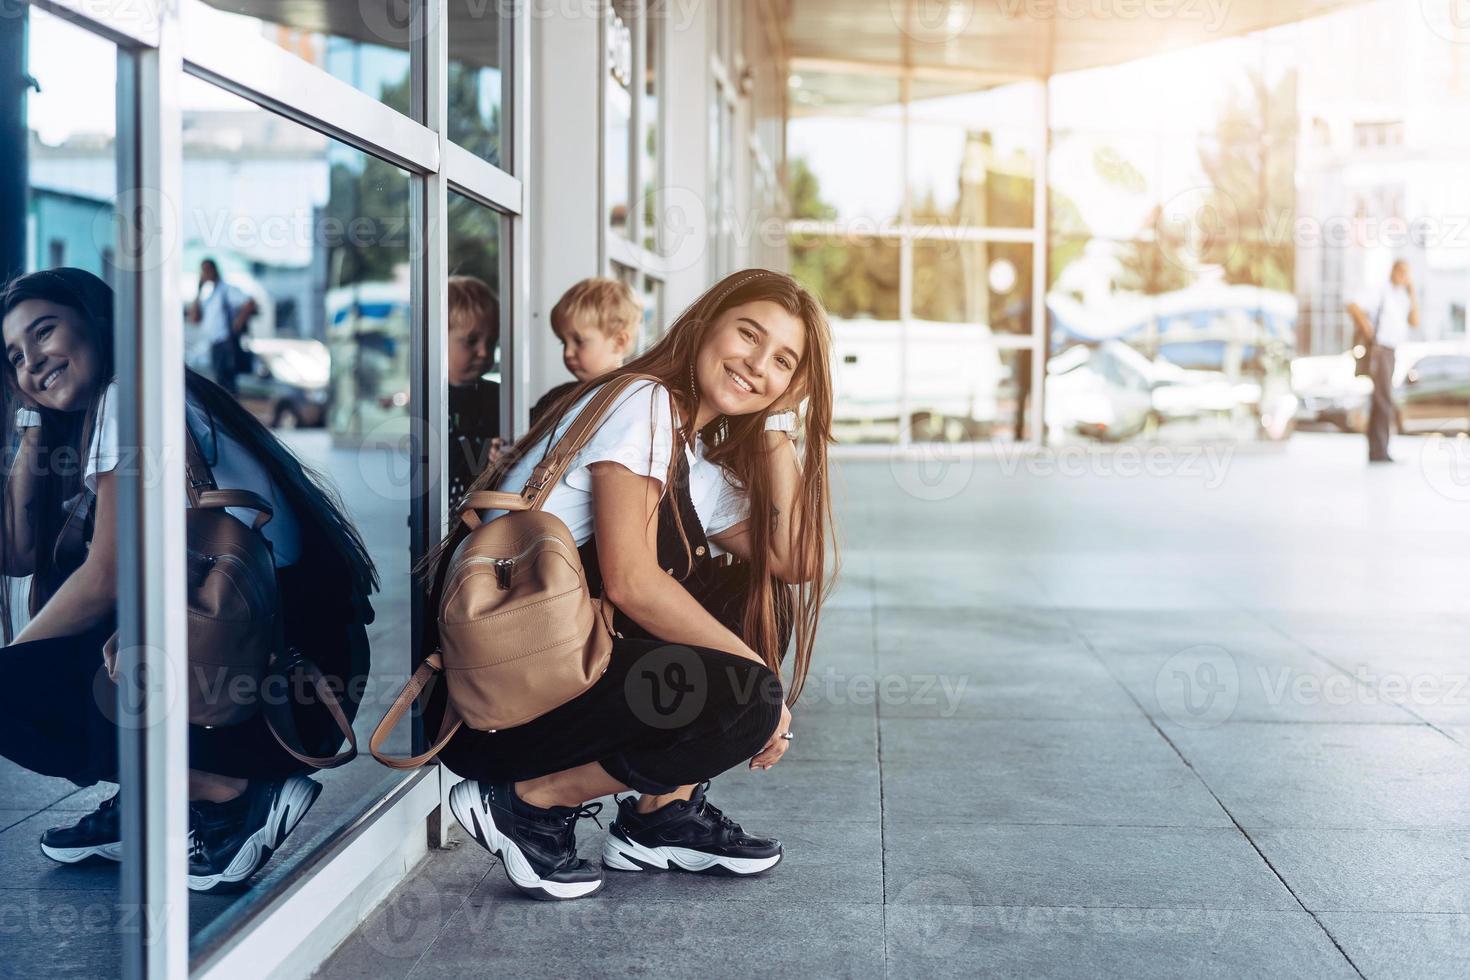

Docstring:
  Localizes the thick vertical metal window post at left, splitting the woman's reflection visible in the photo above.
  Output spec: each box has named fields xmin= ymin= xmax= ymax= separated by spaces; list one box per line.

xmin=115 ymin=16 xmax=188 ymax=980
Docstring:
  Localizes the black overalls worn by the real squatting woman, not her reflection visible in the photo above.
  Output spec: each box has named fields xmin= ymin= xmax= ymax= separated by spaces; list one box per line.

xmin=423 ymin=440 xmax=789 ymax=793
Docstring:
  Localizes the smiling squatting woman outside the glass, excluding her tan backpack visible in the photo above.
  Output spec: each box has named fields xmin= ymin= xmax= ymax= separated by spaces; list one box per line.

xmin=425 ymin=270 xmax=832 ymax=898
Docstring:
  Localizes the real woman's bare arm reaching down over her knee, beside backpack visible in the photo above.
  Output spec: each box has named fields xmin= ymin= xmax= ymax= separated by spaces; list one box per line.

xmin=589 ymin=461 xmax=764 ymax=663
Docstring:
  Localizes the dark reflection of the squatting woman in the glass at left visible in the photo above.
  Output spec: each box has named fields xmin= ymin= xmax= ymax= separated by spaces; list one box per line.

xmin=0 ymin=269 xmax=376 ymax=890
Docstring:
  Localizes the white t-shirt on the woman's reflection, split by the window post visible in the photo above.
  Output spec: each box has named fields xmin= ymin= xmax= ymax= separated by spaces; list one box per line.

xmin=82 ymin=381 xmax=301 ymax=569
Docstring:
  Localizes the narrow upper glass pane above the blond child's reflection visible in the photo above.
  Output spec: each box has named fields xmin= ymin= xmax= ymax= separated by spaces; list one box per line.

xmin=448 ymin=0 xmax=512 ymax=170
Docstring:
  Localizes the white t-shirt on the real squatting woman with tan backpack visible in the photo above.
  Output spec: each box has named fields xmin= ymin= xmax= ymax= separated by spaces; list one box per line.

xmin=482 ymin=381 xmax=750 ymax=554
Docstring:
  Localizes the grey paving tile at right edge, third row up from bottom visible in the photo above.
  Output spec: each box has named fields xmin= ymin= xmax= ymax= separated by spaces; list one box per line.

xmin=1161 ymin=723 xmax=1470 ymax=829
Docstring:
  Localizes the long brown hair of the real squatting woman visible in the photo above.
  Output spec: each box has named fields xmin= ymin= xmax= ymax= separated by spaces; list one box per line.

xmin=419 ymin=269 xmax=838 ymax=704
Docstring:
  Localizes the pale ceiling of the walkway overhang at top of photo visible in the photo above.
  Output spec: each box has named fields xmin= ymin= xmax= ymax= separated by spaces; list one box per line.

xmin=786 ymin=0 xmax=1370 ymax=78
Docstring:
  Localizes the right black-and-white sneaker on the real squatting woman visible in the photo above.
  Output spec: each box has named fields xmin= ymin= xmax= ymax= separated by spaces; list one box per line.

xmin=603 ymin=780 xmax=781 ymax=876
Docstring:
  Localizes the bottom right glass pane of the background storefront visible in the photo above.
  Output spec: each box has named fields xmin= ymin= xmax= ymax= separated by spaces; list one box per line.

xmin=904 ymin=340 xmax=1030 ymax=442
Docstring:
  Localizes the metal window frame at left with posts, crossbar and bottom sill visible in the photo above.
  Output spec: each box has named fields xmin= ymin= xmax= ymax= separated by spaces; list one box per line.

xmin=31 ymin=0 xmax=531 ymax=980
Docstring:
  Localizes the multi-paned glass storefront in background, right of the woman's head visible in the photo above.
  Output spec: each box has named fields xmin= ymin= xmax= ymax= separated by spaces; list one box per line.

xmin=786 ymin=68 xmax=1044 ymax=444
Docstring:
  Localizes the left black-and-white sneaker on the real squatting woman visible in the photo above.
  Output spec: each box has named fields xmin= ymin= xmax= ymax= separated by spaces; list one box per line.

xmin=450 ymin=779 xmax=603 ymax=901
